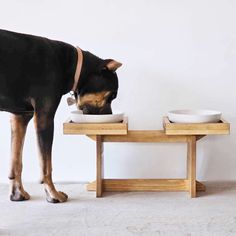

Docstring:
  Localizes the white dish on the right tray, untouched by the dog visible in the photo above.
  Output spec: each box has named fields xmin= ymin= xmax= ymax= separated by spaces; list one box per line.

xmin=168 ymin=110 xmax=221 ymax=123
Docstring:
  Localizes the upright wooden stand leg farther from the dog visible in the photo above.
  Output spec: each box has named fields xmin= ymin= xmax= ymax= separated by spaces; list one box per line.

xmin=187 ymin=136 xmax=197 ymax=198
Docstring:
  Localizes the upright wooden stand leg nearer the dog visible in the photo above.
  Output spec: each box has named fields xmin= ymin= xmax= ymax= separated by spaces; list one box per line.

xmin=96 ymin=135 xmax=104 ymax=197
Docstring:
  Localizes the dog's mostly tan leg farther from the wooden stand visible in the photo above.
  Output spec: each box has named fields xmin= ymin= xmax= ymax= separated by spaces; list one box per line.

xmin=9 ymin=113 xmax=33 ymax=201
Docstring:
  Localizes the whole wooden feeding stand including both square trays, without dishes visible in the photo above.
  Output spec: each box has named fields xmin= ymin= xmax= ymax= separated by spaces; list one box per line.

xmin=64 ymin=117 xmax=229 ymax=198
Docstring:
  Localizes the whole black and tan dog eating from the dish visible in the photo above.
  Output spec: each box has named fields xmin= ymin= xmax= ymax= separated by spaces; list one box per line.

xmin=0 ymin=30 xmax=121 ymax=203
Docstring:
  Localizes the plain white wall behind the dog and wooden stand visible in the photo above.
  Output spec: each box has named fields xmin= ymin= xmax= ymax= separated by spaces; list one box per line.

xmin=0 ymin=0 xmax=236 ymax=182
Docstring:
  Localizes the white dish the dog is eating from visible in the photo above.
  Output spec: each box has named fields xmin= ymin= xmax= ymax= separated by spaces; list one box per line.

xmin=70 ymin=110 xmax=124 ymax=123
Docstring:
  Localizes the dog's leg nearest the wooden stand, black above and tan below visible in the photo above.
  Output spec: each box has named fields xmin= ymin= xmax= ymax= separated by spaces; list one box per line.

xmin=35 ymin=111 xmax=68 ymax=203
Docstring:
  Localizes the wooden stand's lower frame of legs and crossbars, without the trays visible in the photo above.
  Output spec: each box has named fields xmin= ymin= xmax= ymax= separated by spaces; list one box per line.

xmin=87 ymin=131 xmax=205 ymax=197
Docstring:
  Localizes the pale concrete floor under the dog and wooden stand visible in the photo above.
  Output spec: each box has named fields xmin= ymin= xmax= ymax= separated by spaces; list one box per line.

xmin=0 ymin=183 xmax=236 ymax=236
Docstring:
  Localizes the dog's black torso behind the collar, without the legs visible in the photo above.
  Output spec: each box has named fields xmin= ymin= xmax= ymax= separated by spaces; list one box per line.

xmin=0 ymin=30 xmax=76 ymax=113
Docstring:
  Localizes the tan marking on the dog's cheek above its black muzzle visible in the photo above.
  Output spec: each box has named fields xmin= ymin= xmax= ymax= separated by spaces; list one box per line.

xmin=77 ymin=91 xmax=111 ymax=107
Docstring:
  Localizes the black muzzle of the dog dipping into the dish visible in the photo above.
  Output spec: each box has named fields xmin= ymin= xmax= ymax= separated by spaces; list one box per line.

xmin=79 ymin=104 xmax=112 ymax=115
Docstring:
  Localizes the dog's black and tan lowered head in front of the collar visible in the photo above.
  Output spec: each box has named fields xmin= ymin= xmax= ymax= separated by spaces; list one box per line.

xmin=76 ymin=53 xmax=122 ymax=114
